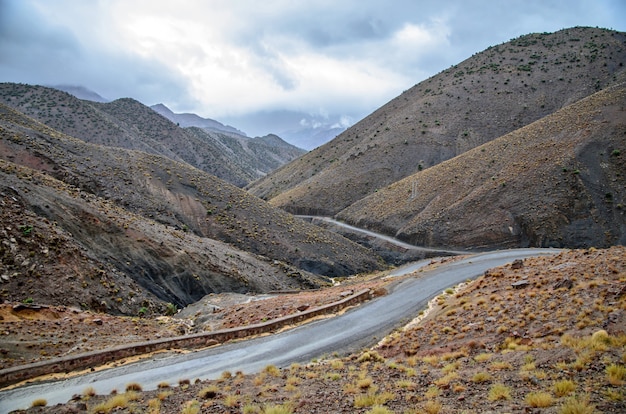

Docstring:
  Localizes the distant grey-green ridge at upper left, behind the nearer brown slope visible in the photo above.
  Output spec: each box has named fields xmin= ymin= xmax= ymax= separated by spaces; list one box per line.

xmin=0 ymin=83 xmax=305 ymax=187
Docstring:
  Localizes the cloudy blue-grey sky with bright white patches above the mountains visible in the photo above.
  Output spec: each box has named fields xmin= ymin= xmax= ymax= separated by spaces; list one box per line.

xmin=0 ymin=0 xmax=626 ymax=134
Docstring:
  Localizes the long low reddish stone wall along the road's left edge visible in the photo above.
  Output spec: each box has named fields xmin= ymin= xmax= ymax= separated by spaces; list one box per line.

xmin=0 ymin=289 xmax=371 ymax=387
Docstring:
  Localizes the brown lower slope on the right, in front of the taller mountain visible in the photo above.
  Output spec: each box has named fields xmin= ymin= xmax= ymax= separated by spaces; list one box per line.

xmin=338 ymin=83 xmax=626 ymax=248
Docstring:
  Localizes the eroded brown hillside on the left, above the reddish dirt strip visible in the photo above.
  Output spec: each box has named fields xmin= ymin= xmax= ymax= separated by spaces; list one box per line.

xmin=0 ymin=105 xmax=382 ymax=313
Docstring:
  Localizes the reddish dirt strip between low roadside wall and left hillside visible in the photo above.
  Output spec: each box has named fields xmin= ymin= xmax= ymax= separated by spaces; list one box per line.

xmin=0 ymin=280 xmax=387 ymax=369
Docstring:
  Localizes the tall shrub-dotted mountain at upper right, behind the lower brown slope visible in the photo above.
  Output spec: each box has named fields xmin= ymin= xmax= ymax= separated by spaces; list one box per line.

xmin=249 ymin=27 xmax=626 ymax=215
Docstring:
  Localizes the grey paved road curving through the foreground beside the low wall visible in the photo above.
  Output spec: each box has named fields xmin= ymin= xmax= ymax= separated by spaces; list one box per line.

xmin=0 ymin=249 xmax=558 ymax=413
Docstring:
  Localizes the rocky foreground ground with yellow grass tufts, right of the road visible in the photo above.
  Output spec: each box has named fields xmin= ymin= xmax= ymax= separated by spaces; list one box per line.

xmin=3 ymin=247 xmax=626 ymax=414
